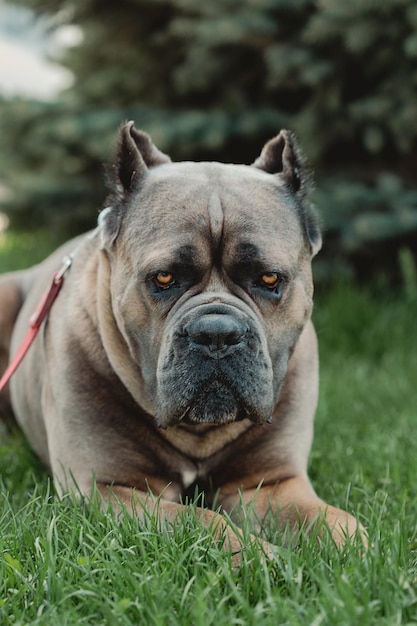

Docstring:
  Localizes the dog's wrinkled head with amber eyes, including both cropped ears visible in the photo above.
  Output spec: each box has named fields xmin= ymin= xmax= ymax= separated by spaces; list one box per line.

xmin=104 ymin=125 xmax=320 ymax=427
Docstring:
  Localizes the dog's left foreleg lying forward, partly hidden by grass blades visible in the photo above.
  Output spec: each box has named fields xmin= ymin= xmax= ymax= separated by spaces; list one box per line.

xmin=97 ymin=483 xmax=271 ymax=568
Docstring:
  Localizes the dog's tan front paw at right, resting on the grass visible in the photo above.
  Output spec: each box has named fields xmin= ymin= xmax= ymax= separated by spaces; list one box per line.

xmin=220 ymin=476 xmax=367 ymax=548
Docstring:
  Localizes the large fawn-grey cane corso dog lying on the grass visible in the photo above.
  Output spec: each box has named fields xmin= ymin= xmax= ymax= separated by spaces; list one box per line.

xmin=0 ymin=122 xmax=365 ymax=562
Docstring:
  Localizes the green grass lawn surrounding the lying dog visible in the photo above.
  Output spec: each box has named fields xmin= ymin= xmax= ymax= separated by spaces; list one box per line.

xmin=0 ymin=232 xmax=417 ymax=626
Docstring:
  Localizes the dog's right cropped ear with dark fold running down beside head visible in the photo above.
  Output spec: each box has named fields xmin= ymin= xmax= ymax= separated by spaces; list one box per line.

xmin=252 ymin=130 xmax=322 ymax=256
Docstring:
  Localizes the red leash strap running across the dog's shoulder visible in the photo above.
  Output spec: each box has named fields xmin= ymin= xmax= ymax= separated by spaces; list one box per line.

xmin=0 ymin=256 xmax=72 ymax=392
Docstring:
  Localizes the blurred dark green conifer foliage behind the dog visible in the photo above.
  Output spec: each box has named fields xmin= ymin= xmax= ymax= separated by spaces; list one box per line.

xmin=0 ymin=0 xmax=417 ymax=279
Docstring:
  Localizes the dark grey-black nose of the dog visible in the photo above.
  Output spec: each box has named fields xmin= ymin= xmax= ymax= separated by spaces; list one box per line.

xmin=187 ymin=313 xmax=247 ymax=357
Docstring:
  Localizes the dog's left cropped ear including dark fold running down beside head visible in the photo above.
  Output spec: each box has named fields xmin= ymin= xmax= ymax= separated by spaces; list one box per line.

xmin=101 ymin=122 xmax=171 ymax=248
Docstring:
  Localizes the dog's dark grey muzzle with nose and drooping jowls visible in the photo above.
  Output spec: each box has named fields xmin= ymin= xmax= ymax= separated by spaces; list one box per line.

xmin=156 ymin=302 xmax=274 ymax=427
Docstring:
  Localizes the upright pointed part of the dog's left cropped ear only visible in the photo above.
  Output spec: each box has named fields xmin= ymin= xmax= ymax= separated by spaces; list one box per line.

xmin=114 ymin=122 xmax=171 ymax=192
